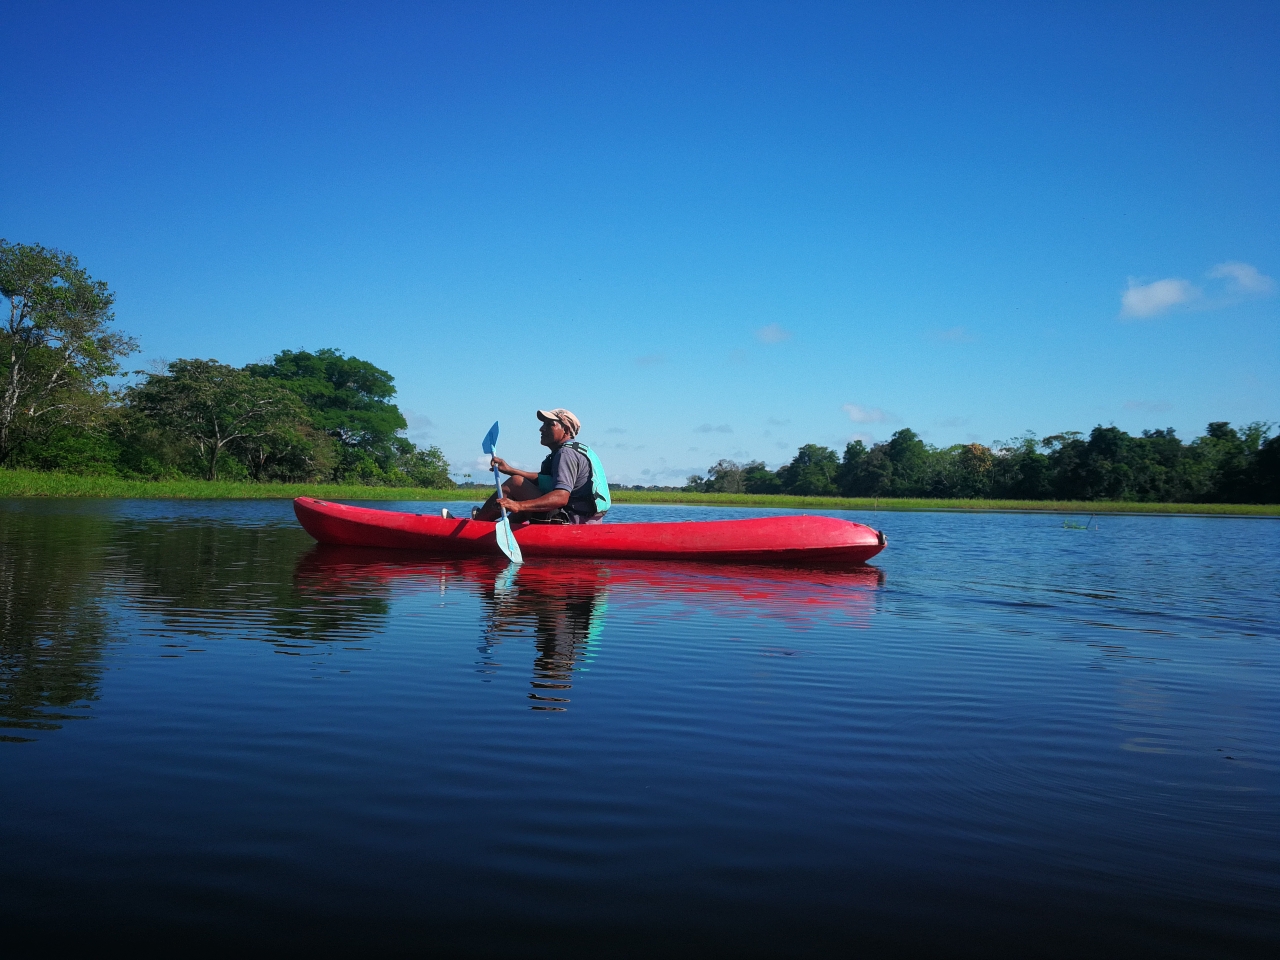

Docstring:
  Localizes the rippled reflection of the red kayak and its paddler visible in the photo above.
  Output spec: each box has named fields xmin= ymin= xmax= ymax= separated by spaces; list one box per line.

xmin=296 ymin=547 xmax=884 ymax=710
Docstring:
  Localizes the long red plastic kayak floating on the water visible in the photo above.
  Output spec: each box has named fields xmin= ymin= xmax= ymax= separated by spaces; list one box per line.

xmin=293 ymin=497 xmax=884 ymax=563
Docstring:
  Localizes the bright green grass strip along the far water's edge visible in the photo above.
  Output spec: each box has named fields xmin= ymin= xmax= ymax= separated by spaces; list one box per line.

xmin=0 ymin=470 xmax=1280 ymax=517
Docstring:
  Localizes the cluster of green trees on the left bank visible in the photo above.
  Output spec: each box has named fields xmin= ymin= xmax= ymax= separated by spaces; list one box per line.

xmin=0 ymin=239 xmax=453 ymax=489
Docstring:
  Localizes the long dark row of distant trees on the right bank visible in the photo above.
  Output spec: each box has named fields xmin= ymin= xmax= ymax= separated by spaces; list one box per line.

xmin=685 ymin=422 xmax=1280 ymax=503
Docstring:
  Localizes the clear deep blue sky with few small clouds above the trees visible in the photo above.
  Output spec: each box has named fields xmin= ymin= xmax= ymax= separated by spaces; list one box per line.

xmin=0 ymin=3 xmax=1280 ymax=483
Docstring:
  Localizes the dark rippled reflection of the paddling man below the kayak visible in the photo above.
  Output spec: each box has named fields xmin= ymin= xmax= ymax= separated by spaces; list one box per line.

xmin=480 ymin=566 xmax=608 ymax=710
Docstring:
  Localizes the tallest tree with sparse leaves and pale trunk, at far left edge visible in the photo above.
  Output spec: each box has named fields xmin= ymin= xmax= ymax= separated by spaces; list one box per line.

xmin=0 ymin=239 xmax=137 ymax=463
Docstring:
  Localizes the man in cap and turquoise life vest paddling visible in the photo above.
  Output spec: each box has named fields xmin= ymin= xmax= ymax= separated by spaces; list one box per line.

xmin=472 ymin=407 xmax=611 ymax=524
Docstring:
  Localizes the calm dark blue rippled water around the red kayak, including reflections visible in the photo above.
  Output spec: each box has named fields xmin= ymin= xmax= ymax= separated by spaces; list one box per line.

xmin=0 ymin=500 xmax=1280 ymax=957
